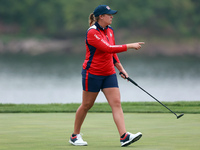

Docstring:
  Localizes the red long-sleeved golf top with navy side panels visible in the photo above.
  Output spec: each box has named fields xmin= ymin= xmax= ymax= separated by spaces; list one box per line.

xmin=83 ymin=22 xmax=127 ymax=76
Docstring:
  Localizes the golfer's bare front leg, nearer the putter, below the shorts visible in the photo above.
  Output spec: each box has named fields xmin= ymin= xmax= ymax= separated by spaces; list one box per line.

xmin=103 ymin=88 xmax=126 ymax=136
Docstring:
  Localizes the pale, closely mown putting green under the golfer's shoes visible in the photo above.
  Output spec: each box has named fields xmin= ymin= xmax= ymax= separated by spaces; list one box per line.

xmin=0 ymin=113 xmax=200 ymax=150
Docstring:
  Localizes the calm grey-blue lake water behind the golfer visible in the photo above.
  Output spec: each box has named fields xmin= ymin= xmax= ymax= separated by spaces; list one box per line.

xmin=0 ymin=53 xmax=200 ymax=104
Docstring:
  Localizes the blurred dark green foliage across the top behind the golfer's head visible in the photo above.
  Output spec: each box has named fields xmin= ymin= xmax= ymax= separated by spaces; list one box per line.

xmin=0 ymin=0 xmax=200 ymax=37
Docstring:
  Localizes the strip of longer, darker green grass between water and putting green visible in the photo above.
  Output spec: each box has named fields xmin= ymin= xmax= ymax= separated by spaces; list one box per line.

xmin=0 ymin=101 xmax=200 ymax=114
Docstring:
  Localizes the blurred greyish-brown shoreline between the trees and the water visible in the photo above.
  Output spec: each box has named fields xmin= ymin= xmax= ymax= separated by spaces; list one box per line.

xmin=0 ymin=37 xmax=200 ymax=57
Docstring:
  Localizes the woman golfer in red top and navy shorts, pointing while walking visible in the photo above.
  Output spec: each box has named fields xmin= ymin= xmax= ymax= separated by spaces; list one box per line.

xmin=69 ymin=5 xmax=144 ymax=146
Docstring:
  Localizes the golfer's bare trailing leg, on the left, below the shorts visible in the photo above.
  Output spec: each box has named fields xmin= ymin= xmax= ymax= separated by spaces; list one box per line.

xmin=74 ymin=91 xmax=99 ymax=134
